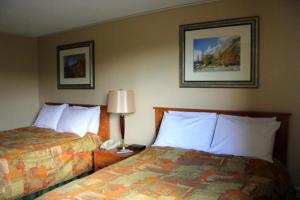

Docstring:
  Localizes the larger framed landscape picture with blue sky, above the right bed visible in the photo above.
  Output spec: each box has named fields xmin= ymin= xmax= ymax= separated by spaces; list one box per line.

xmin=179 ymin=17 xmax=259 ymax=88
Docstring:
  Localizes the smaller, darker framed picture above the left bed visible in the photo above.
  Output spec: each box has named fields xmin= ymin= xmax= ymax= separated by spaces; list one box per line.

xmin=56 ymin=41 xmax=95 ymax=89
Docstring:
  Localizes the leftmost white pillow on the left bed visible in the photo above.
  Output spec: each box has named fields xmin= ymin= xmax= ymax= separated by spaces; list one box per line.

xmin=33 ymin=104 xmax=68 ymax=129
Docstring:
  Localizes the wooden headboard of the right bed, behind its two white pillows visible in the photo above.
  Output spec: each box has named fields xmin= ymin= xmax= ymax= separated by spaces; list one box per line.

xmin=154 ymin=107 xmax=291 ymax=165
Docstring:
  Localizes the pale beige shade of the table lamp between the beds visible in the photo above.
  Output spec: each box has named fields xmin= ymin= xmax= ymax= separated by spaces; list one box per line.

xmin=107 ymin=90 xmax=135 ymax=114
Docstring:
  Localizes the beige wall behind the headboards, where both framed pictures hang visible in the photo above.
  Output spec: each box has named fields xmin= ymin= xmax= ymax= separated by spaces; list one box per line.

xmin=38 ymin=0 xmax=300 ymax=184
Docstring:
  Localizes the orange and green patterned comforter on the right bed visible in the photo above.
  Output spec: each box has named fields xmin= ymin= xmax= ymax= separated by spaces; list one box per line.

xmin=39 ymin=147 xmax=288 ymax=200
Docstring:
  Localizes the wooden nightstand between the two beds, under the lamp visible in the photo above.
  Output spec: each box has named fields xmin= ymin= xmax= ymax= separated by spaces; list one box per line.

xmin=94 ymin=149 xmax=141 ymax=171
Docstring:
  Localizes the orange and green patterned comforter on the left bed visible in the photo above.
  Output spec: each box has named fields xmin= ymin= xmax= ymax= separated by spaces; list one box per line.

xmin=0 ymin=127 xmax=100 ymax=199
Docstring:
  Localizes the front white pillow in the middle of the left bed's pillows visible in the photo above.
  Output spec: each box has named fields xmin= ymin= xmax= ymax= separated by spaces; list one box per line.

xmin=56 ymin=107 xmax=94 ymax=137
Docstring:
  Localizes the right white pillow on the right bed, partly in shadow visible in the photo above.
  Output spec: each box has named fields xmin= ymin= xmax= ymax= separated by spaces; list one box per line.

xmin=209 ymin=115 xmax=280 ymax=162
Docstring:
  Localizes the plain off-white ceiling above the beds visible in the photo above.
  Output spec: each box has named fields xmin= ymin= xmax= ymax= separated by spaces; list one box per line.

xmin=0 ymin=0 xmax=211 ymax=37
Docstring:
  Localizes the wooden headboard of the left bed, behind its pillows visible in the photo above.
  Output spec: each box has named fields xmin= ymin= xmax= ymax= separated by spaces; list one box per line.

xmin=46 ymin=102 xmax=110 ymax=141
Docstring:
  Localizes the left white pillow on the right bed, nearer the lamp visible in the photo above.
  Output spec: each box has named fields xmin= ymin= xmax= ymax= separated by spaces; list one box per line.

xmin=153 ymin=113 xmax=217 ymax=151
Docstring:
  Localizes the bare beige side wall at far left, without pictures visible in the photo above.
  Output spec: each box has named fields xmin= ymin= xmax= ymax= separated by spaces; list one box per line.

xmin=0 ymin=34 xmax=39 ymax=130
